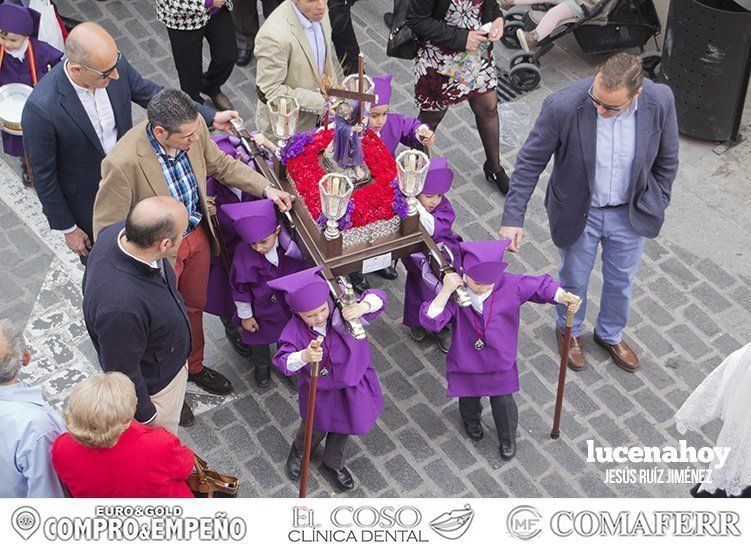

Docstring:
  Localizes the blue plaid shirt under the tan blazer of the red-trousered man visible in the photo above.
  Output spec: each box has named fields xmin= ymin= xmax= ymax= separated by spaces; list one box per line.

xmin=146 ymin=123 xmax=203 ymax=236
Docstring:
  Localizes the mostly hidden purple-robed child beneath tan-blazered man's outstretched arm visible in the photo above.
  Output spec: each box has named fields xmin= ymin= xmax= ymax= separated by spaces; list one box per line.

xmin=204 ymin=134 xmax=256 ymax=357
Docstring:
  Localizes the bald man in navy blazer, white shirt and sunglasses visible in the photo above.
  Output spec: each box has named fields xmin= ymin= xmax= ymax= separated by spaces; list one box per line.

xmin=22 ymin=23 xmax=237 ymax=263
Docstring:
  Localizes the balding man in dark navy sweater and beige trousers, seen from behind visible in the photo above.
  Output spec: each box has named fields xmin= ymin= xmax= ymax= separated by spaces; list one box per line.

xmin=83 ymin=196 xmax=190 ymax=433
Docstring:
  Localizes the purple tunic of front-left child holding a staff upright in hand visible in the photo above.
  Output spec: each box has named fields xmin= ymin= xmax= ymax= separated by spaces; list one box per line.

xmin=274 ymin=289 xmax=386 ymax=435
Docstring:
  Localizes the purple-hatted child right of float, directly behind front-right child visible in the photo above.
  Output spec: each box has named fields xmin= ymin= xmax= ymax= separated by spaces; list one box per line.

xmin=402 ymin=157 xmax=462 ymax=353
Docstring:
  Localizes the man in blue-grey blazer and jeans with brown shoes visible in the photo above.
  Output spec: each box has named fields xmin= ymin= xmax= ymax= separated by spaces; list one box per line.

xmin=500 ymin=53 xmax=678 ymax=372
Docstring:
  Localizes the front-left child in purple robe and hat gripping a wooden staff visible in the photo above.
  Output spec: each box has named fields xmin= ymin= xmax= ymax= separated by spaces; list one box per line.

xmin=269 ymin=266 xmax=386 ymax=490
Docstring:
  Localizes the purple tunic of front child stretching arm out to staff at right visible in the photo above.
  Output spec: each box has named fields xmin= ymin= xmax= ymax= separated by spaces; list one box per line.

xmin=420 ymin=273 xmax=561 ymax=397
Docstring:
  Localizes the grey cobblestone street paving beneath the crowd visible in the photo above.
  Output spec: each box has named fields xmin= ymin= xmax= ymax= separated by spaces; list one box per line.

xmin=0 ymin=0 xmax=751 ymax=497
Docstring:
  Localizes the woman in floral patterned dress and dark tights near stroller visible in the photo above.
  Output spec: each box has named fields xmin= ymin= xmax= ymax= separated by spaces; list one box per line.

xmin=407 ymin=0 xmax=509 ymax=194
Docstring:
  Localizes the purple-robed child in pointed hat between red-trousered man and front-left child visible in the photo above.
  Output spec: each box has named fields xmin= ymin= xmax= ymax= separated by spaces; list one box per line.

xmin=222 ymin=199 xmax=308 ymax=387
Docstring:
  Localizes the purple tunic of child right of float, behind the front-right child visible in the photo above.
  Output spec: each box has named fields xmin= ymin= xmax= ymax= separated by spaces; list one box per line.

xmin=402 ymin=196 xmax=462 ymax=327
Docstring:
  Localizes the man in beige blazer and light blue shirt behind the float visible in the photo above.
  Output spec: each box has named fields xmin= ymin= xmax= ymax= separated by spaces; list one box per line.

xmin=255 ymin=0 xmax=341 ymax=141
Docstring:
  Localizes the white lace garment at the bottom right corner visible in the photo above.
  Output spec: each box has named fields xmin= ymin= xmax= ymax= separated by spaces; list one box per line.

xmin=675 ymin=343 xmax=751 ymax=498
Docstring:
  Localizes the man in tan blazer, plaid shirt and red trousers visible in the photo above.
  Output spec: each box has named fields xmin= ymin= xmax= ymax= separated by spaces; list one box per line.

xmin=94 ymin=89 xmax=291 ymax=421
